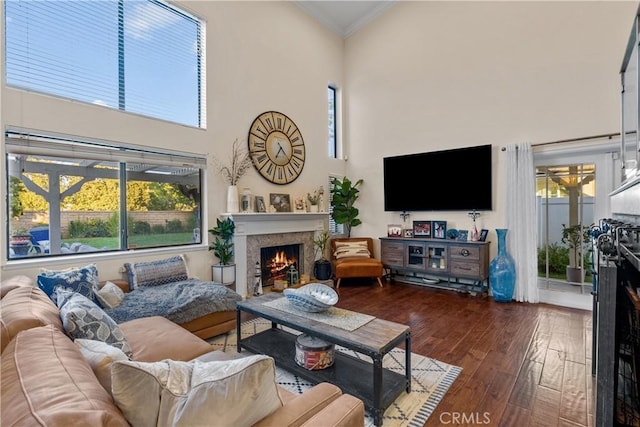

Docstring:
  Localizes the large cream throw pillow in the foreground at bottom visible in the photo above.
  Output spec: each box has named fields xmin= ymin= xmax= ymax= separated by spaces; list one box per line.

xmin=111 ymin=355 xmax=282 ymax=427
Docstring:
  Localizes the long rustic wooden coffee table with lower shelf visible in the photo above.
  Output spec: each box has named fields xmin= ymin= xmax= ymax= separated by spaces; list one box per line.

xmin=236 ymin=293 xmax=411 ymax=426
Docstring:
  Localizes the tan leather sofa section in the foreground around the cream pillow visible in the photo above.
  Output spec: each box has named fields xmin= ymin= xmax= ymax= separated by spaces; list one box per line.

xmin=0 ymin=276 xmax=364 ymax=427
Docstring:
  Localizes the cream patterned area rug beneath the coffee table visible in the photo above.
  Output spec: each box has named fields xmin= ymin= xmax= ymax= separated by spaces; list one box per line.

xmin=209 ymin=318 xmax=462 ymax=427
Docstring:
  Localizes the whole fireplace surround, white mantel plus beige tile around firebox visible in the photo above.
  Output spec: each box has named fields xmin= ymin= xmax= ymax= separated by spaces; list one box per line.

xmin=228 ymin=213 xmax=329 ymax=298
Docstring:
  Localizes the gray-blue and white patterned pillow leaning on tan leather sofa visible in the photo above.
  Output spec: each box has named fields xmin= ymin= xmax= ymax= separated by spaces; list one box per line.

xmin=56 ymin=288 xmax=131 ymax=357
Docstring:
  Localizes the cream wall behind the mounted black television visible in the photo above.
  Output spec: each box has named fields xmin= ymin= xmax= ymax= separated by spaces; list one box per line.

xmin=345 ymin=1 xmax=637 ymax=256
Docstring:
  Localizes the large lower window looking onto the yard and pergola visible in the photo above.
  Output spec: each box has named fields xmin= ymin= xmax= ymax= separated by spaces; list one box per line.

xmin=6 ymin=131 xmax=206 ymax=259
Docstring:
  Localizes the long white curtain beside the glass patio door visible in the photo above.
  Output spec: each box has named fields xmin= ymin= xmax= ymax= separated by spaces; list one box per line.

xmin=506 ymin=143 xmax=539 ymax=303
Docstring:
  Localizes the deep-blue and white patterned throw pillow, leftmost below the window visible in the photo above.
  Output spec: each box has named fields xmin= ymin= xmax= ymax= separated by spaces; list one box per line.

xmin=37 ymin=264 xmax=100 ymax=304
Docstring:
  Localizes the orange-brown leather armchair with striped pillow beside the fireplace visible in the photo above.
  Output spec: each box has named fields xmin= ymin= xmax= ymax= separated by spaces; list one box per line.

xmin=331 ymin=237 xmax=383 ymax=289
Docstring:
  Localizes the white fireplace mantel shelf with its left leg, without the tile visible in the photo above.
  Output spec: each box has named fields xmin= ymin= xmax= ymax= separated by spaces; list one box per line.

xmin=222 ymin=212 xmax=329 ymax=298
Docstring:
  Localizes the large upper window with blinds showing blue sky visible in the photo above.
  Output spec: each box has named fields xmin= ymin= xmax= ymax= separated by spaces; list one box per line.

xmin=3 ymin=0 xmax=206 ymax=128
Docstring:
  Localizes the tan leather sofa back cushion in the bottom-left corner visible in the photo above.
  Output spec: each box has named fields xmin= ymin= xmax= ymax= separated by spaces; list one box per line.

xmin=0 ymin=325 xmax=128 ymax=427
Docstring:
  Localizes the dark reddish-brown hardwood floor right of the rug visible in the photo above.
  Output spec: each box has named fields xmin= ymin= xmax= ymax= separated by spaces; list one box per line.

xmin=337 ymin=280 xmax=593 ymax=427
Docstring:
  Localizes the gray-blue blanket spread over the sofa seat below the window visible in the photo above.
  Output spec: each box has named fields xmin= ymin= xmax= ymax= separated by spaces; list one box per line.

xmin=105 ymin=279 xmax=242 ymax=324
